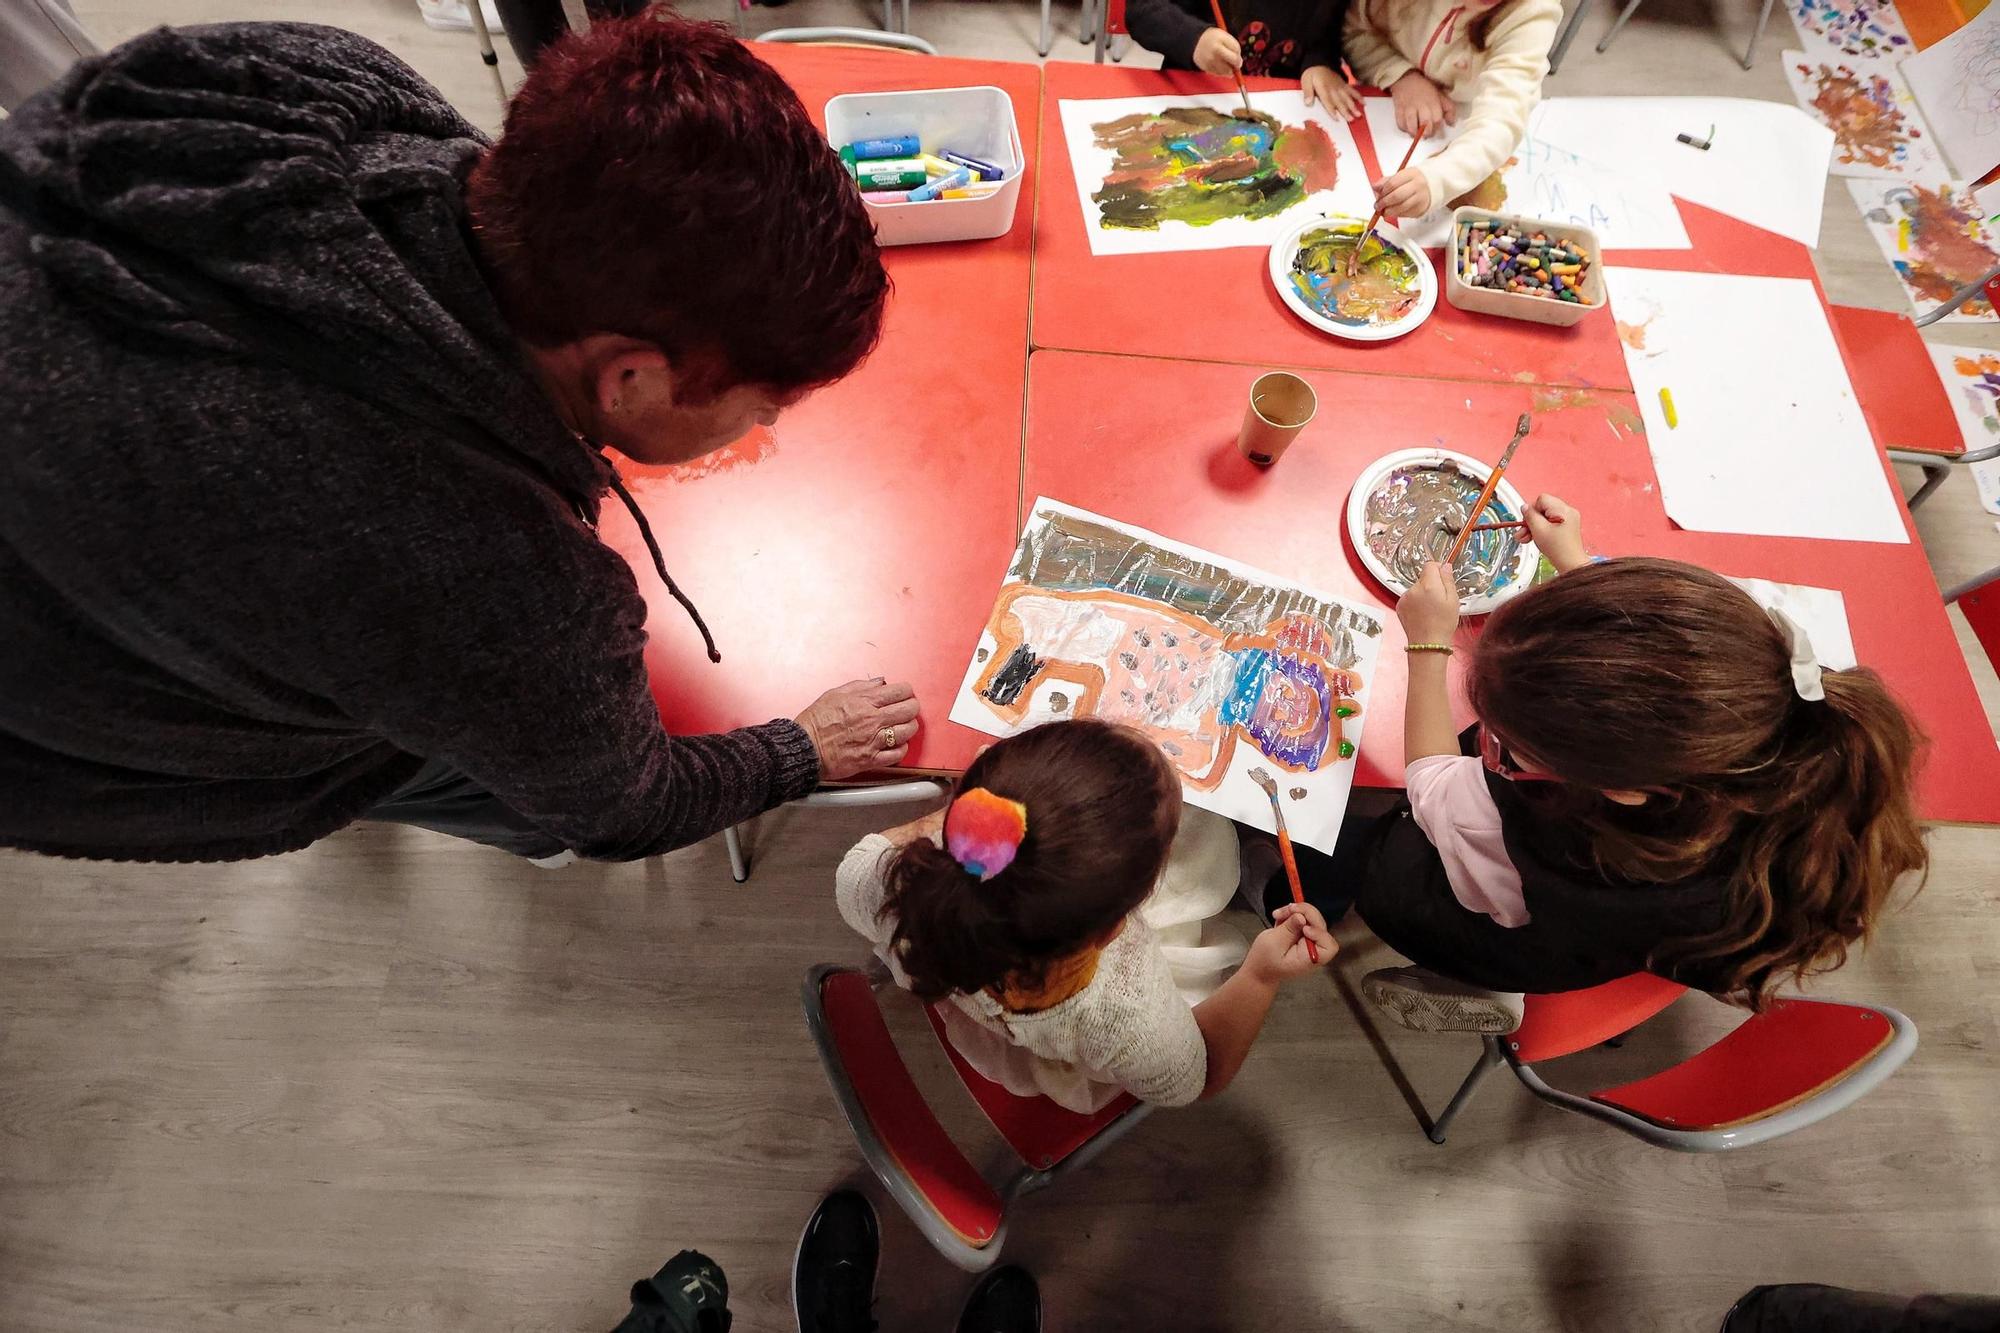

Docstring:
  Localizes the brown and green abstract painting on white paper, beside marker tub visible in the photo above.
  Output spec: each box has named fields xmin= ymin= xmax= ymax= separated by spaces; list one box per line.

xmin=1060 ymin=92 xmax=1374 ymax=254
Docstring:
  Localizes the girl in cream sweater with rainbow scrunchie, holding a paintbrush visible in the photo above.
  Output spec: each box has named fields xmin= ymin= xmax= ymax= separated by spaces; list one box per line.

xmin=836 ymin=719 xmax=1336 ymax=1113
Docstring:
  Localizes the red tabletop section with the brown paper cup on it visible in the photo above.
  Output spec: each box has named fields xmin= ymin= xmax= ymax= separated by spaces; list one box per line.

xmin=1024 ymin=342 xmax=2000 ymax=823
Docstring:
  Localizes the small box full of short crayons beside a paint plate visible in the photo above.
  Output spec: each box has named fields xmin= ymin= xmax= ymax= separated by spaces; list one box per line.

xmin=1444 ymin=208 xmax=1604 ymax=326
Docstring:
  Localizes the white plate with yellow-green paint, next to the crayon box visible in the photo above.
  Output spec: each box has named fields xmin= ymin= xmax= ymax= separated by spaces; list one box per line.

xmin=1270 ymin=214 xmax=1438 ymax=342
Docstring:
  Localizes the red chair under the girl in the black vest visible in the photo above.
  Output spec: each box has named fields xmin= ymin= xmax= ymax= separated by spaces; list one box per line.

xmin=1428 ymin=973 xmax=1916 ymax=1153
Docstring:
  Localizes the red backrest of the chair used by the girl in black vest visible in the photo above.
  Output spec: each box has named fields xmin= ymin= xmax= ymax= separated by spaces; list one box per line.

xmin=1590 ymin=999 xmax=1896 ymax=1129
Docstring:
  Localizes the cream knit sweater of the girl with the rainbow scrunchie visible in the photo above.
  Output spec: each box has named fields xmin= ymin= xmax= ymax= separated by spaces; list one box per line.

xmin=834 ymin=809 xmax=1242 ymax=1115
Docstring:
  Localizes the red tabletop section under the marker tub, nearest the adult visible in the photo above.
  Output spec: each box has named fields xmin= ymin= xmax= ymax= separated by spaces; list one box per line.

xmin=604 ymin=44 xmax=1042 ymax=769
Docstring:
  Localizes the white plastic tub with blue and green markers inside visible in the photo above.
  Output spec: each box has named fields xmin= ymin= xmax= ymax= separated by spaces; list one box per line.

xmin=826 ymin=88 xmax=1026 ymax=246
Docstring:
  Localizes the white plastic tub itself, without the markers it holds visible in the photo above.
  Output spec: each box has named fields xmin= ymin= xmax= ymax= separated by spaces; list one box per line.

xmin=826 ymin=86 xmax=1026 ymax=246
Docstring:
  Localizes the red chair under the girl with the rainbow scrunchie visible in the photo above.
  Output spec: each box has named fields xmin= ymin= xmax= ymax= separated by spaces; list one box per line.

xmin=802 ymin=963 xmax=1152 ymax=1273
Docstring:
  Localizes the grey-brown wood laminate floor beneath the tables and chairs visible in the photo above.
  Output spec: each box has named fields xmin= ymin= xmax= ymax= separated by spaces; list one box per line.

xmin=0 ymin=0 xmax=2000 ymax=1333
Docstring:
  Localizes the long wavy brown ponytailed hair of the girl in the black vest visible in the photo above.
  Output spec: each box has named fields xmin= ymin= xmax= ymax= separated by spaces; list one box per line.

xmin=1470 ymin=558 xmax=1930 ymax=1009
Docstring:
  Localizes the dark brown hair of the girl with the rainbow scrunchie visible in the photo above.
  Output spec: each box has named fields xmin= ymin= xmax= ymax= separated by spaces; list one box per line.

xmin=882 ymin=719 xmax=1180 ymax=999
